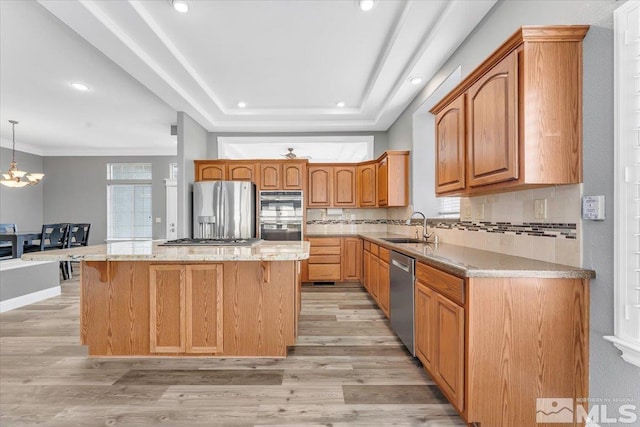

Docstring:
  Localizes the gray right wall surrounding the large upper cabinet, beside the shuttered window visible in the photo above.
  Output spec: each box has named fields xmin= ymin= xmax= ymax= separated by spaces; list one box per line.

xmin=389 ymin=0 xmax=640 ymax=415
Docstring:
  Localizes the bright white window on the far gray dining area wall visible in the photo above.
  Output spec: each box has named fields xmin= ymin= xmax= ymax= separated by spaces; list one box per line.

xmin=107 ymin=163 xmax=153 ymax=240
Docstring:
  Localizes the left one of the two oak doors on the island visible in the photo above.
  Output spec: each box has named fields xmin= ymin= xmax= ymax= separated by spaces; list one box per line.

xmin=149 ymin=265 xmax=186 ymax=353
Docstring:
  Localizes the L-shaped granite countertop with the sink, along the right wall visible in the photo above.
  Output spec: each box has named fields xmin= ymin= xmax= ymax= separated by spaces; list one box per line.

xmin=307 ymin=232 xmax=596 ymax=279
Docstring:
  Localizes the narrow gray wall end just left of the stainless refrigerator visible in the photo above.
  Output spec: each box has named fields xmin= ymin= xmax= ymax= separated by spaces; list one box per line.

xmin=177 ymin=111 xmax=208 ymax=238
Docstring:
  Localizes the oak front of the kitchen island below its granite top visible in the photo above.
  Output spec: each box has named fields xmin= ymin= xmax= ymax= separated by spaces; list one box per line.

xmin=80 ymin=261 xmax=300 ymax=357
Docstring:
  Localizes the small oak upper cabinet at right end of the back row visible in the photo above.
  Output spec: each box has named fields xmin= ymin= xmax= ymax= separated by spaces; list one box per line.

xmin=376 ymin=151 xmax=409 ymax=207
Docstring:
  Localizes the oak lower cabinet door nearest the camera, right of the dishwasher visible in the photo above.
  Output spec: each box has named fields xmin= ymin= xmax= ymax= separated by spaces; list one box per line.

xmin=434 ymin=294 xmax=465 ymax=411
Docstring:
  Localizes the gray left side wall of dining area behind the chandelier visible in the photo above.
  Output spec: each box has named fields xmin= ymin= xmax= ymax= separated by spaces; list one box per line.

xmin=0 ymin=147 xmax=43 ymax=231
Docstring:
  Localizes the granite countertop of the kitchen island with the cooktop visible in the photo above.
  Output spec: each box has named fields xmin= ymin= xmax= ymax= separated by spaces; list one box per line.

xmin=22 ymin=240 xmax=309 ymax=262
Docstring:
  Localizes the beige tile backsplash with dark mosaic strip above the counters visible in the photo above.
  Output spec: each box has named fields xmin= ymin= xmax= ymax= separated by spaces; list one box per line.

xmin=307 ymin=184 xmax=582 ymax=267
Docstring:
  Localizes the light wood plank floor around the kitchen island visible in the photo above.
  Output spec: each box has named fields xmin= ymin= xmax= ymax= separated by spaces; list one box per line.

xmin=0 ymin=279 xmax=464 ymax=427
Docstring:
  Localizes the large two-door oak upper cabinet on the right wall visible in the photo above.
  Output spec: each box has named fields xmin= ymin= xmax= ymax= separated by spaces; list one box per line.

xmin=431 ymin=26 xmax=589 ymax=195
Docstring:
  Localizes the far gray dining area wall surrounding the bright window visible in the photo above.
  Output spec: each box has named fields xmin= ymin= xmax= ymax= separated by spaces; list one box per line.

xmin=43 ymin=156 xmax=176 ymax=245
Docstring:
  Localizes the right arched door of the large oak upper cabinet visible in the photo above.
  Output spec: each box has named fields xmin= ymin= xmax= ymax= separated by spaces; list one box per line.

xmin=467 ymin=52 xmax=518 ymax=187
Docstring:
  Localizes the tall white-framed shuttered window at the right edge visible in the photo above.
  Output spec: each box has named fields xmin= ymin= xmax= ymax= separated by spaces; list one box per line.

xmin=605 ymin=1 xmax=640 ymax=367
